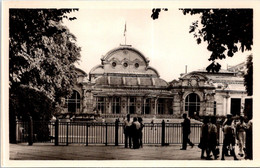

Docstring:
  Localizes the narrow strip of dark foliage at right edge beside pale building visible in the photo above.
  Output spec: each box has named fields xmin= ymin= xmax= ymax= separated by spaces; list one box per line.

xmin=244 ymin=55 xmax=253 ymax=96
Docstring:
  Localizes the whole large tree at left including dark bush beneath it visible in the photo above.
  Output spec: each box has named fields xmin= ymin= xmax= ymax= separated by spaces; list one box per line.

xmin=9 ymin=9 xmax=80 ymax=142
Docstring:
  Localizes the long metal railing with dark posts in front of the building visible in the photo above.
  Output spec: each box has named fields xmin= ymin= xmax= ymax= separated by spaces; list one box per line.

xmin=17 ymin=120 xmax=223 ymax=145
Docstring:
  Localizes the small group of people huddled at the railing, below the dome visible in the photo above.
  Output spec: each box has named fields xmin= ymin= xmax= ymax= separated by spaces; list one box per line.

xmin=124 ymin=114 xmax=144 ymax=149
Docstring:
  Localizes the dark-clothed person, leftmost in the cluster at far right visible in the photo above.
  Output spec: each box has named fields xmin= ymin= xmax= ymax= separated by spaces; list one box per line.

xmin=198 ymin=116 xmax=209 ymax=159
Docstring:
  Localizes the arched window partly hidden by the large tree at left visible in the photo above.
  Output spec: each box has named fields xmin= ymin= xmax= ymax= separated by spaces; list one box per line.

xmin=66 ymin=90 xmax=80 ymax=113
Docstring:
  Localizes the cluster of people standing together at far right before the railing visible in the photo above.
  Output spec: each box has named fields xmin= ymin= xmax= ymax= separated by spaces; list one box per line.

xmin=199 ymin=115 xmax=252 ymax=160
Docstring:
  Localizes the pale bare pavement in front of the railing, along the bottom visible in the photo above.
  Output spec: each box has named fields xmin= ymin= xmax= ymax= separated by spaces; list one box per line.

xmin=10 ymin=143 xmax=244 ymax=161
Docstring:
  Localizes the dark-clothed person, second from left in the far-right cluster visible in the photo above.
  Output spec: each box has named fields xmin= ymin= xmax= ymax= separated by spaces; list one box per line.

xmin=207 ymin=116 xmax=219 ymax=160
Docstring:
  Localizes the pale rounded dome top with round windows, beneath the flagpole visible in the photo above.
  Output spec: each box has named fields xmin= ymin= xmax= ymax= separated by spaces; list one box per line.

xmin=90 ymin=45 xmax=159 ymax=77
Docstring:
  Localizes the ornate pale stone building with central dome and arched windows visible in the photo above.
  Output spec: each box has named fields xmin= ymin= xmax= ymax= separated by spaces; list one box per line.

xmin=62 ymin=45 xmax=252 ymax=118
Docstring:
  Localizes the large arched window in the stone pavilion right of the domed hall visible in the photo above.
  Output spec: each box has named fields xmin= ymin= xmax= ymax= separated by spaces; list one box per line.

xmin=185 ymin=93 xmax=200 ymax=116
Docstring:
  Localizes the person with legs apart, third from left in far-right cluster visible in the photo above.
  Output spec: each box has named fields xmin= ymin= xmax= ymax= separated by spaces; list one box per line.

xmin=221 ymin=117 xmax=238 ymax=160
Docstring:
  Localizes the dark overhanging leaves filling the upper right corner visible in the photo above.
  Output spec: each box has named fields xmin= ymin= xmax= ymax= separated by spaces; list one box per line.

xmin=182 ymin=9 xmax=253 ymax=72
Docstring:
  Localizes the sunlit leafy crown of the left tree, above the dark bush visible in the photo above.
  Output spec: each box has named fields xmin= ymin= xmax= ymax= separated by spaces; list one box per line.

xmin=9 ymin=9 xmax=80 ymax=102
